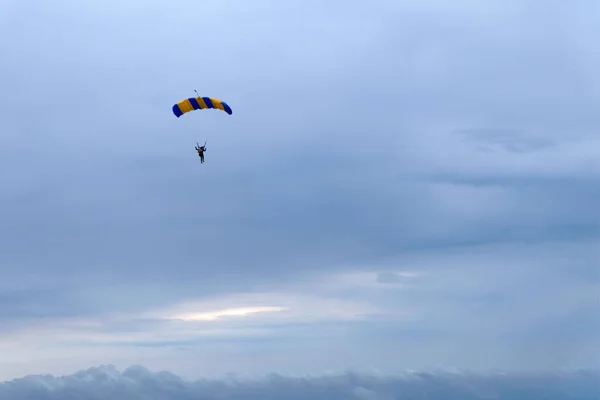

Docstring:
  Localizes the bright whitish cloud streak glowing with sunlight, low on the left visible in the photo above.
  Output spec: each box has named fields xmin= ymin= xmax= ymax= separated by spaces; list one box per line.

xmin=0 ymin=271 xmax=404 ymax=360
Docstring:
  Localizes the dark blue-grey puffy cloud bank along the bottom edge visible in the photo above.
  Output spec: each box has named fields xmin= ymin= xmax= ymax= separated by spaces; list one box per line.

xmin=0 ymin=365 xmax=600 ymax=400
